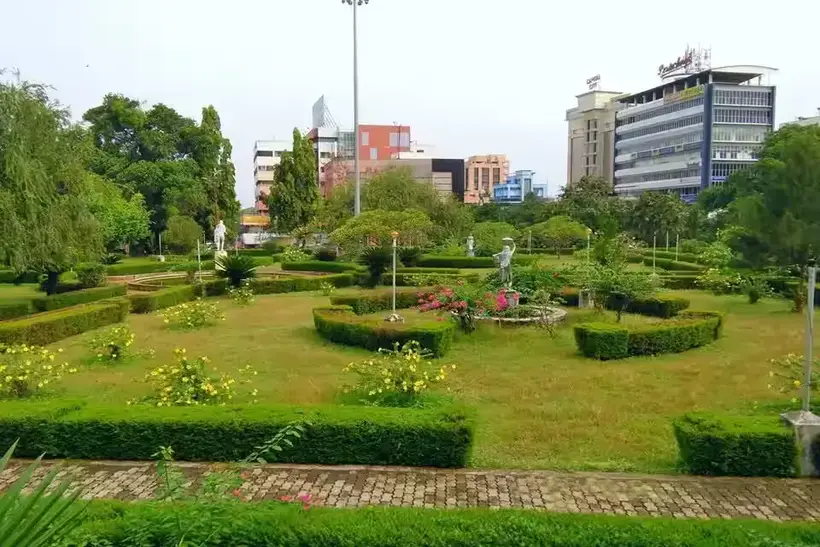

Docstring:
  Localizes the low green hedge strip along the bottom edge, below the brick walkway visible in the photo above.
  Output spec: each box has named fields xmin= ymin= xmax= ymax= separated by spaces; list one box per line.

xmin=68 ymin=501 xmax=820 ymax=547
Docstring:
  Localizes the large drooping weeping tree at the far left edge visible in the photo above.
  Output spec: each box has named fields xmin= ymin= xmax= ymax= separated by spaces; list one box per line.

xmin=0 ymin=79 xmax=102 ymax=293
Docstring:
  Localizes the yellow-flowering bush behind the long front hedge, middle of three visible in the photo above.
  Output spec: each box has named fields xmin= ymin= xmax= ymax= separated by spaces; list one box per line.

xmin=145 ymin=349 xmax=256 ymax=407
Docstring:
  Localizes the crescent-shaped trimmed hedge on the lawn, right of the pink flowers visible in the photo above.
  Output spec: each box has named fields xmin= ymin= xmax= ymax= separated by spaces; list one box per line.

xmin=575 ymin=312 xmax=723 ymax=360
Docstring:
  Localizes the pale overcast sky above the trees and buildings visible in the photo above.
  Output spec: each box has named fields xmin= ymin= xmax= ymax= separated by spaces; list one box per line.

xmin=0 ymin=0 xmax=820 ymax=206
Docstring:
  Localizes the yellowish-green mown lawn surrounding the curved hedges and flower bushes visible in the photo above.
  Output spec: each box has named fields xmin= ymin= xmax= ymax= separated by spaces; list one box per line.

xmin=41 ymin=289 xmax=804 ymax=472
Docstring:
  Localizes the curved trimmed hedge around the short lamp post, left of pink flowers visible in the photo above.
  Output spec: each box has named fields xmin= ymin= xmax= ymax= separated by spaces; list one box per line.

xmin=313 ymin=306 xmax=456 ymax=357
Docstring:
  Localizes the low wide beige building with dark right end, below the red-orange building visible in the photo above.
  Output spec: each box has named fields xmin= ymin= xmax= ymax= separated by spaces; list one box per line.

xmin=321 ymin=158 xmax=464 ymax=201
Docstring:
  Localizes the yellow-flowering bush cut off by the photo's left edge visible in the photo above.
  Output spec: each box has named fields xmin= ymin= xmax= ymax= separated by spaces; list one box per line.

xmin=0 ymin=344 xmax=77 ymax=398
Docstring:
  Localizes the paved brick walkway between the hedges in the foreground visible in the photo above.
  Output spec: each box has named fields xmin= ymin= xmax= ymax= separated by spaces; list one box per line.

xmin=0 ymin=462 xmax=820 ymax=521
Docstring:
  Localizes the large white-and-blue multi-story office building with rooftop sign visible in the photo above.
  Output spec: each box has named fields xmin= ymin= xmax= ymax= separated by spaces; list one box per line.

xmin=614 ymin=64 xmax=775 ymax=201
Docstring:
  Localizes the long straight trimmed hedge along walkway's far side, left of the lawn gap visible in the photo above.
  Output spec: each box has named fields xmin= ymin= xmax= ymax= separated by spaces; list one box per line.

xmin=0 ymin=401 xmax=473 ymax=467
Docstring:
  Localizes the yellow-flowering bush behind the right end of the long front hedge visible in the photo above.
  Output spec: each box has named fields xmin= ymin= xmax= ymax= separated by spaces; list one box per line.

xmin=343 ymin=340 xmax=456 ymax=406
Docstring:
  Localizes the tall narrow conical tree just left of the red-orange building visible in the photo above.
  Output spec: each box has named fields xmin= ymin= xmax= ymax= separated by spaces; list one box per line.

xmin=268 ymin=129 xmax=319 ymax=232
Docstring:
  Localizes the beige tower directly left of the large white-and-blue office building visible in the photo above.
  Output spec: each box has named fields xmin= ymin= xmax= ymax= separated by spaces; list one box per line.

xmin=566 ymin=89 xmax=622 ymax=184
